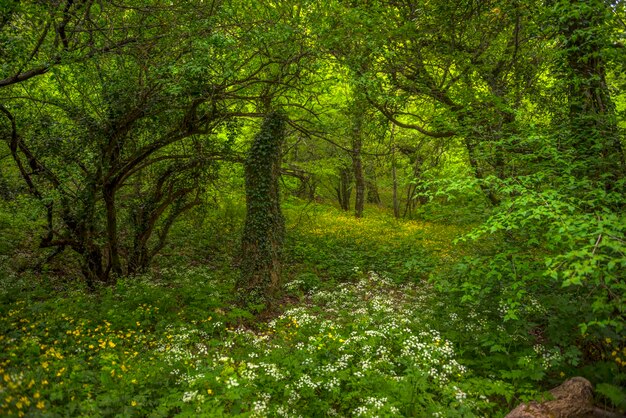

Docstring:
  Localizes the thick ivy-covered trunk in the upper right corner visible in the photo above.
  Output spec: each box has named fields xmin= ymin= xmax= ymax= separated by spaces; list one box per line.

xmin=556 ymin=0 xmax=624 ymax=188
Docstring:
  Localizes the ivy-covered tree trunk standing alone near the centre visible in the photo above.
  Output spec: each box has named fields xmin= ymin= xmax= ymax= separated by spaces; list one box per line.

xmin=237 ymin=112 xmax=285 ymax=304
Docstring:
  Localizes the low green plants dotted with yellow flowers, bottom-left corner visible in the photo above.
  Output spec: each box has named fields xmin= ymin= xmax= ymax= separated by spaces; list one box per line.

xmin=0 ymin=269 xmax=233 ymax=416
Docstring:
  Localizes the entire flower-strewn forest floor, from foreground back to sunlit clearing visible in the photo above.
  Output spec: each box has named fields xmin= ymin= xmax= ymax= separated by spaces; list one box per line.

xmin=0 ymin=205 xmax=608 ymax=417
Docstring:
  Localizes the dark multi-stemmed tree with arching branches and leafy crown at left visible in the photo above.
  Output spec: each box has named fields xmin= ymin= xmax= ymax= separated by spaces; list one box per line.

xmin=0 ymin=2 xmax=266 ymax=289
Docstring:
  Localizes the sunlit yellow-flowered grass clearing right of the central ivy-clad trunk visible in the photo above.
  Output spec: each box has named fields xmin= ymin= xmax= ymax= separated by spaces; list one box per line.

xmin=286 ymin=202 xmax=469 ymax=282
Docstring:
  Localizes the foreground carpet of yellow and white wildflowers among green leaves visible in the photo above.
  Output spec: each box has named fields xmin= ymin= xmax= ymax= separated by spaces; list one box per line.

xmin=0 ymin=269 xmax=496 ymax=416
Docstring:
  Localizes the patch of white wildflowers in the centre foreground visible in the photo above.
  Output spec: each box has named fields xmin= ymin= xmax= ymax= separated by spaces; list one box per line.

xmin=159 ymin=272 xmax=469 ymax=416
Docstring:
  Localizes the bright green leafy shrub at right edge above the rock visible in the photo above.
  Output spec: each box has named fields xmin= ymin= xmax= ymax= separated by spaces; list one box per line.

xmin=434 ymin=172 xmax=626 ymax=406
